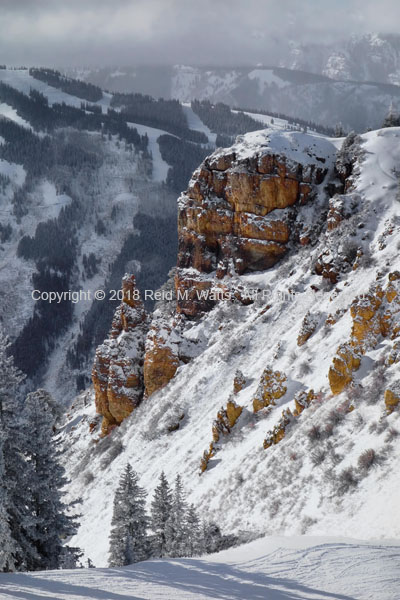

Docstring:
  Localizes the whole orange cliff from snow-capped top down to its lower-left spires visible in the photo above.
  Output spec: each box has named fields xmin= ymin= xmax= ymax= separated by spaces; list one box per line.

xmin=93 ymin=131 xmax=334 ymax=433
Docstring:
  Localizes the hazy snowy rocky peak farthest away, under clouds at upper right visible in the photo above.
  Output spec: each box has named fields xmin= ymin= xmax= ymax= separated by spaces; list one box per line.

xmin=285 ymin=33 xmax=400 ymax=85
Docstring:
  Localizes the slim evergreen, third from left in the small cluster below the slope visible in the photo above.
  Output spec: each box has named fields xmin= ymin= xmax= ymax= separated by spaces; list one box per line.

xmin=165 ymin=475 xmax=188 ymax=557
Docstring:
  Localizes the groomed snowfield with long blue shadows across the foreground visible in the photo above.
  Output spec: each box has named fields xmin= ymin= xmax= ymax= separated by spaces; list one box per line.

xmin=0 ymin=537 xmax=400 ymax=600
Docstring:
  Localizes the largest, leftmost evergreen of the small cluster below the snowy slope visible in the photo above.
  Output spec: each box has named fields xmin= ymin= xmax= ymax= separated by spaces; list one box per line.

xmin=109 ymin=464 xmax=149 ymax=567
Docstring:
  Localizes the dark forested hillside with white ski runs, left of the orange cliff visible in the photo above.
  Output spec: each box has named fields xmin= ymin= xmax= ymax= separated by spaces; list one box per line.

xmin=0 ymin=69 xmax=188 ymax=395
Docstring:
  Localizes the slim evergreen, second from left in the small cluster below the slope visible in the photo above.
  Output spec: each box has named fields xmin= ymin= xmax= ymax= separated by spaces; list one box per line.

xmin=151 ymin=472 xmax=172 ymax=557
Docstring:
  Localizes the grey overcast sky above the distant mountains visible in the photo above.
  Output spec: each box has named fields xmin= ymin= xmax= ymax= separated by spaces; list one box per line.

xmin=0 ymin=0 xmax=400 ymax=66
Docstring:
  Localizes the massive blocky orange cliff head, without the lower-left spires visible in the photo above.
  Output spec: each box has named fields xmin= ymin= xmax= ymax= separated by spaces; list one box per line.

xmin=176 ymin=134 xmax=327 ymax=317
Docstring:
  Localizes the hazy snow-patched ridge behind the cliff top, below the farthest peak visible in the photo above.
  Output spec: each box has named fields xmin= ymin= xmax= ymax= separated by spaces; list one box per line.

xmin=176 ymin=68 xmax=400 ymax=131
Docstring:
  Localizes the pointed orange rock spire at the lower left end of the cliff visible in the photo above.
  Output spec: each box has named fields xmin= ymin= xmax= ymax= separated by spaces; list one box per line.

xmin=92 ymin=275 xmax=148 ymax=434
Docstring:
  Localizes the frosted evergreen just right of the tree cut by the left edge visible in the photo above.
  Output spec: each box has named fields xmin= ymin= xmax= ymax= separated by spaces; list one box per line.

xmin=24 ymin=390 xmax=79 ymax=570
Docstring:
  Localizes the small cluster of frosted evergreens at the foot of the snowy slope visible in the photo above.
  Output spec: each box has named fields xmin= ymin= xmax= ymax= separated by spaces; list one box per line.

xmin=109 ymin=464 xmax=236 ymax=567
